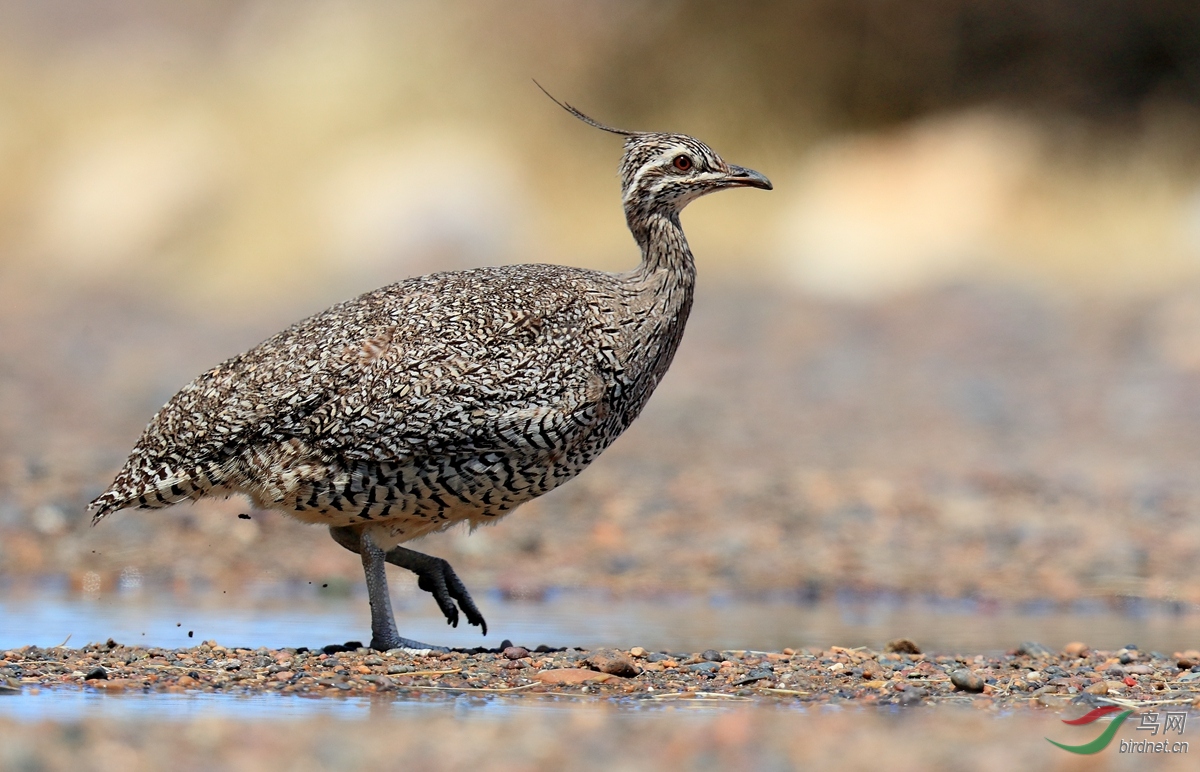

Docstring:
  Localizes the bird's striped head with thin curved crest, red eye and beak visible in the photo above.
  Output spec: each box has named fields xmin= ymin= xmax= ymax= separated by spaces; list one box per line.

xmin=538 ymin=84 xmax=772 ymax=223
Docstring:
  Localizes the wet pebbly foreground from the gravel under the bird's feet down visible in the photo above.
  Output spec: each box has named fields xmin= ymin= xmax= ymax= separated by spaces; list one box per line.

xmin=0 ymin=641 xmax=1200 ymax=771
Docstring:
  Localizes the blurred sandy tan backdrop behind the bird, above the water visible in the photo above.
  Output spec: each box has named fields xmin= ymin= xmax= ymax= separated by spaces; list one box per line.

xmin=0 ymin=0 xmax=1200 ymax=604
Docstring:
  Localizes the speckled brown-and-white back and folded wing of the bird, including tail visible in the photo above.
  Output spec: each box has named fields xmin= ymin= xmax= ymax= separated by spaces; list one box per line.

xmin=92 ymin=265 xmax=619 ymax=516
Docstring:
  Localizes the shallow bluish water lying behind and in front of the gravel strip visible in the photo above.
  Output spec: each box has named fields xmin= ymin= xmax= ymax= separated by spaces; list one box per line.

xmin=0 ymin=587 xmax=1200 ymax=720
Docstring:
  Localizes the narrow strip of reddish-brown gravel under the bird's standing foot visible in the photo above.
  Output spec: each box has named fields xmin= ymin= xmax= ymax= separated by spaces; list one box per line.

xmin=7 ymin=639 xmax=1200 ymax=708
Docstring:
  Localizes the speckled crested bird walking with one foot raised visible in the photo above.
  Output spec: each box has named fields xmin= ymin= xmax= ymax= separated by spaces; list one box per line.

xmin=89 ymin=82 xmax=772 ymax=651
